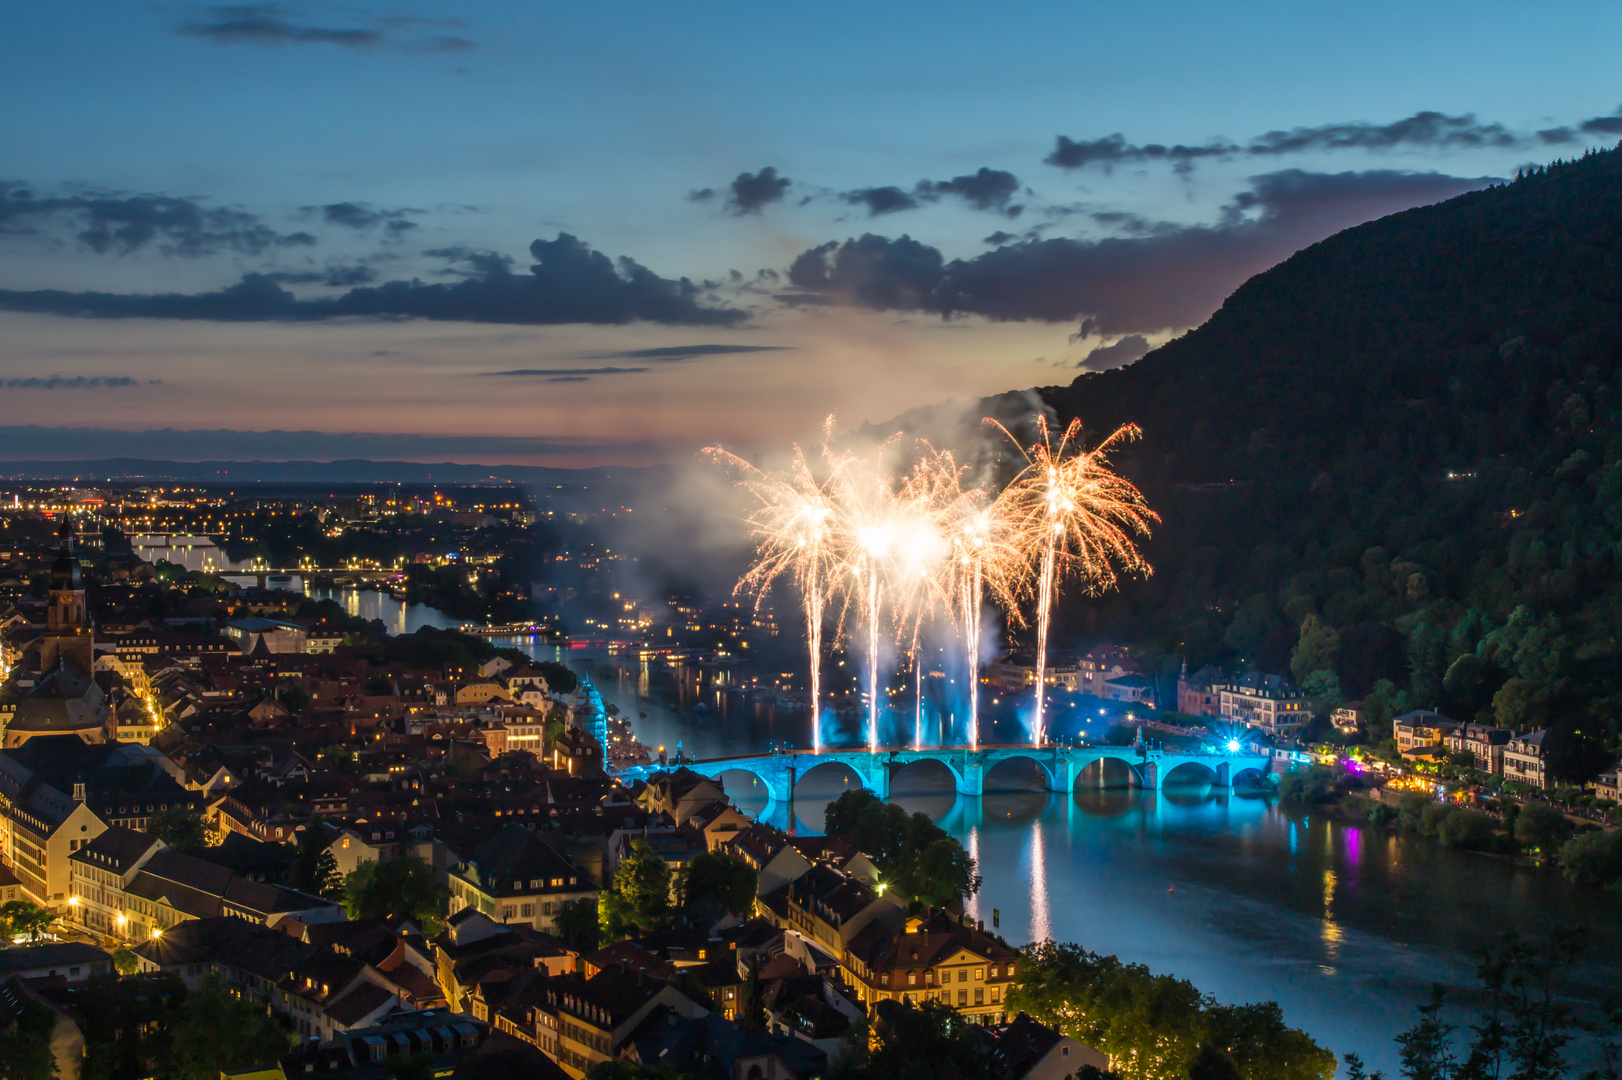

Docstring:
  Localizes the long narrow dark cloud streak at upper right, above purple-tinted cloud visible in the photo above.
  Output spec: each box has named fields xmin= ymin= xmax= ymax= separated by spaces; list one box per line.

xmin=1043 ymin=110 xmax=1531 ymax=172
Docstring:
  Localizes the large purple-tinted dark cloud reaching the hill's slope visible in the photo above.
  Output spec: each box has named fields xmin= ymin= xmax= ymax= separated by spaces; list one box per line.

xmin=779 ymin=170 xmax=1491 ymax=336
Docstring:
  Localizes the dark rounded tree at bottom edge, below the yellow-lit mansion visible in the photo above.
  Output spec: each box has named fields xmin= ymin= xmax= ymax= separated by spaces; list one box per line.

xmin=834 ymin=1001 xmax=991 ymax=1080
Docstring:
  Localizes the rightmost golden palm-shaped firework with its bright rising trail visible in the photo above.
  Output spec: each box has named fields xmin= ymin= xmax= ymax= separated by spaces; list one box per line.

xmin=988 ymin=417 xmax=1160 ymax=746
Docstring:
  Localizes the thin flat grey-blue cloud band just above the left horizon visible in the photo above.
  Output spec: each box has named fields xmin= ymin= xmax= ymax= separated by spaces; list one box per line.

xmin=0 ymin=425 xmax=663 ymax=462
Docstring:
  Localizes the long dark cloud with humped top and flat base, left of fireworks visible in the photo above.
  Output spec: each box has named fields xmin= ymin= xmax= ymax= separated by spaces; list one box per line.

xmin=0 ymin=232 xmax=749 ymax=326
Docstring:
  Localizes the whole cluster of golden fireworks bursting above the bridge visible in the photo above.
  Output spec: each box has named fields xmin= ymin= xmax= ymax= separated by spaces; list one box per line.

xmin=706 ymin=408 xmax=1158 ymax=752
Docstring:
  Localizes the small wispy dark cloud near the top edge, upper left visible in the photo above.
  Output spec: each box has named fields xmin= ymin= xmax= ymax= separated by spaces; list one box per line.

xmin=175 ymin=3 xmax=478 ymax=52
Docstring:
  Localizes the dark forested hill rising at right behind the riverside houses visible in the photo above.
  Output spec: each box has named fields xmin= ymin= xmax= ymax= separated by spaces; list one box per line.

xmin=1043 ymin=151 xmax=1622 ymax=765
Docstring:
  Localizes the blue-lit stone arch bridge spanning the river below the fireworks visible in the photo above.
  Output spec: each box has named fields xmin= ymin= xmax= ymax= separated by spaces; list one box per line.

xmin=616 ymin=746 xmax=1268 ymax=803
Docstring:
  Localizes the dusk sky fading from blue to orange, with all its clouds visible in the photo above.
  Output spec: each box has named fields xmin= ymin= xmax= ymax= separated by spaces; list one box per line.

xmin=0 ymin=0 xmax=1622 ymax=467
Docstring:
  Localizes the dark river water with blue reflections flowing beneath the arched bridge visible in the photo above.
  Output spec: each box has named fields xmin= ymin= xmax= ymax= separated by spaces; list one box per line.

xmin=335 ymin=594 xmax=1622 ymax=1075
